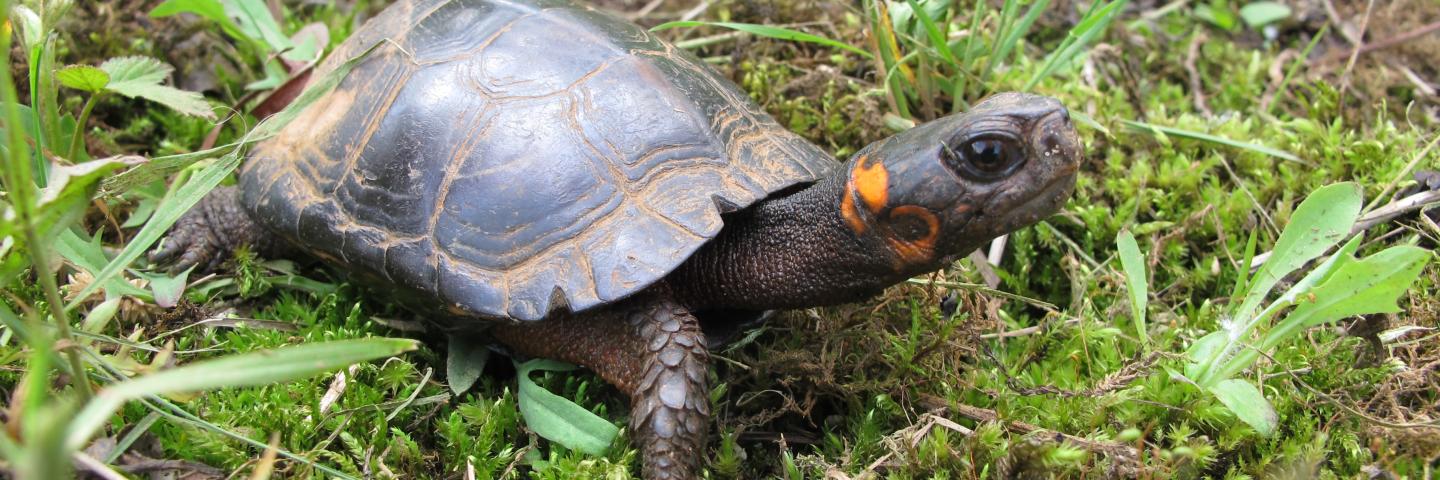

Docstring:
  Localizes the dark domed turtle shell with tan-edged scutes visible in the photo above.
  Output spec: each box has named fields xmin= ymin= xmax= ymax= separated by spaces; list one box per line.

xmin=240 ymin=0 xmax=834 ymax=320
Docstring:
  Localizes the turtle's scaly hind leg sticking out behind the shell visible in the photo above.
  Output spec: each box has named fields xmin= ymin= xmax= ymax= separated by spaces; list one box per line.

xmin=150 ymin=186 xmax=288 ymax=271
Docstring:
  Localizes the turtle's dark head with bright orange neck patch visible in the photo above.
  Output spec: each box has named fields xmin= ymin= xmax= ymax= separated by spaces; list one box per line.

xmin=841 ymin=94 xmax=1081 ymax=266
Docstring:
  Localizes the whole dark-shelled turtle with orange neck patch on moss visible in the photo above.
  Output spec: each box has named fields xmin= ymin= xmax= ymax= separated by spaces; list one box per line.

xmin=151 ymin=0 xmax=1081 ymax=479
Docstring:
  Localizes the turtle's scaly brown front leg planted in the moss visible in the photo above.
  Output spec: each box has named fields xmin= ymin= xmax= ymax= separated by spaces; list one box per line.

xmin=491 ymin=288 xmax=710 ymax=480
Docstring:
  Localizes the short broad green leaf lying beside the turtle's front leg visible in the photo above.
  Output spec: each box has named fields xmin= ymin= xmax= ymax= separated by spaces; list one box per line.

xmin=516 ymin=359 xmax=619 ymax=455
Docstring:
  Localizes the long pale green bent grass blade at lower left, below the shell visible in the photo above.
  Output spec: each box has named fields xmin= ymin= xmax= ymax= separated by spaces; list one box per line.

xmin=66 ymin=339 xmax=419 ymax=448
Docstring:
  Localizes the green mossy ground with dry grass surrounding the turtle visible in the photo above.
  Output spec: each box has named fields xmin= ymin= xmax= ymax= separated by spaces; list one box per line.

xmin=11 ymin=0 xmax=1440 ymax=479
